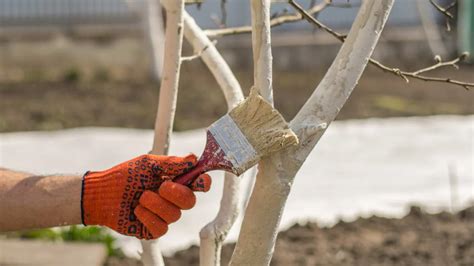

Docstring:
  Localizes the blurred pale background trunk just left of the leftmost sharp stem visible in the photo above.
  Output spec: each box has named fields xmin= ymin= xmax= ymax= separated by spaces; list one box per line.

xmin=143 ymin=0 xmax=165 ymax=81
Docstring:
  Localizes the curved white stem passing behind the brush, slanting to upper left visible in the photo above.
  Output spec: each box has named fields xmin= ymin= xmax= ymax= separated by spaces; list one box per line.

xmin=184 ymin=13 xmax=243 ymax=266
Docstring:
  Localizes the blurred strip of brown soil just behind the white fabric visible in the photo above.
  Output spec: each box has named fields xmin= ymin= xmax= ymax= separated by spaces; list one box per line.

xmin=0 ymin=62 xmax=474 ymax=132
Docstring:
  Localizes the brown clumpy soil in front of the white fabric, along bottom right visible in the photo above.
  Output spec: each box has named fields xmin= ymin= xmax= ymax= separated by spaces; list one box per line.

xmin=165 ymin=206 xmax=474 ymax=266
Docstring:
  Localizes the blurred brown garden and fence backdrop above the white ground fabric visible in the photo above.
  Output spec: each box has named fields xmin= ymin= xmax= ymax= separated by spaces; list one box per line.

xmin=0 ymin=0 xmax=474 ymax=132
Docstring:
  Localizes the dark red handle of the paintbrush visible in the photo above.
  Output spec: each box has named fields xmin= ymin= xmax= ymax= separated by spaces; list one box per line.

xmin=173 ymin=131 xmax=233 ymax=186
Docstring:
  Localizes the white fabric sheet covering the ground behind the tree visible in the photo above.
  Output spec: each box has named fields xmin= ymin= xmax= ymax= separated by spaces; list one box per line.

xmin=0 ymin=116 xmax=474 ymax=255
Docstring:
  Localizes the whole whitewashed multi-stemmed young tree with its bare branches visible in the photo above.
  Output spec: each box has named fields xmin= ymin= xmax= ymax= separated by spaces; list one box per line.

xmin=145 ymin=0 xmax=474 ymax=265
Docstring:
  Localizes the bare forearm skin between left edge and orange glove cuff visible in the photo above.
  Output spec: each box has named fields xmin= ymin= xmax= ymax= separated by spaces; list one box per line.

xmin=0 ymin=168 xmax=82 ymax=231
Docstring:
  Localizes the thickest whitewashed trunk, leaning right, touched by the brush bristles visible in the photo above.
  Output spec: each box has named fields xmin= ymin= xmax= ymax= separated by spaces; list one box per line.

xmin=230 ymin=0 xmax=394 ymax=265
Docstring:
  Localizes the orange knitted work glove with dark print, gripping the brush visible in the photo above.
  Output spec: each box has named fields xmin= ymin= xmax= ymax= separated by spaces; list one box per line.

xmin=81 ymin=154 xmax=211 ymax=239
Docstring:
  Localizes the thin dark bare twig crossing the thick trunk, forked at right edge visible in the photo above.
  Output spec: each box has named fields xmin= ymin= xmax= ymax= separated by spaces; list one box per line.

xmin=288 ymin=0 xmax=474 ymax=90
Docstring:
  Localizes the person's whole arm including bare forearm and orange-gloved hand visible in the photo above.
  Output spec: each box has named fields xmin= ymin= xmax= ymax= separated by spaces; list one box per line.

xmin=0 ymin=155 xmax=211 ymax=239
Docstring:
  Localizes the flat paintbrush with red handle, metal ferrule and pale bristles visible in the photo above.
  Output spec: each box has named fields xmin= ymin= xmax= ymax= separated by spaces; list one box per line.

xmin=174 ymin=89 xmax=298 ymax=185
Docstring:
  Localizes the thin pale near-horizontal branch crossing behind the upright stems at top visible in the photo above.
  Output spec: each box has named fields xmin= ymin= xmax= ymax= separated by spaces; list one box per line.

xmin=204 ymin=1 xmax=331 ymax=37
